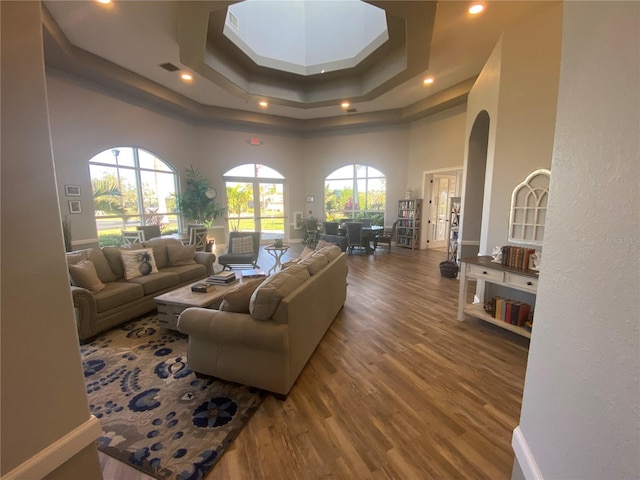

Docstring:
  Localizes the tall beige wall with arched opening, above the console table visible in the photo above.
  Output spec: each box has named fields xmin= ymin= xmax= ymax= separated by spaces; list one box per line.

xmin=461 ymin=3 xmax=562 ymax=254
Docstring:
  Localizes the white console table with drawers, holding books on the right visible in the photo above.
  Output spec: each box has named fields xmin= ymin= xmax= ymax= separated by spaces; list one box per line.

xmin=458 ymin=256 xmax=538 ymax=338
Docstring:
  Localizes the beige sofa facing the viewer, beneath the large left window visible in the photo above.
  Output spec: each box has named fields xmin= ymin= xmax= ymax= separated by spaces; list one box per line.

xmin=67 ymin=239 xmax=216 ymax=341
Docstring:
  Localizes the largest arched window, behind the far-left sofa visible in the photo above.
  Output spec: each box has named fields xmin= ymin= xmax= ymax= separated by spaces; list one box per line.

xmin=89 ymin=147 xmax=178 ymax=246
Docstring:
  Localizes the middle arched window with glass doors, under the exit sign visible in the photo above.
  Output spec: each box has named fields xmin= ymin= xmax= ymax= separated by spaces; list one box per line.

xmin=223 ymin=163 xmax=285 ymax=243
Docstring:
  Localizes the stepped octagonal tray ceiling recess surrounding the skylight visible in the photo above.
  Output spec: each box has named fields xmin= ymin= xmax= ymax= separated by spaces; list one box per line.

xmin=178 ymin=0 xmax=436 ymax=108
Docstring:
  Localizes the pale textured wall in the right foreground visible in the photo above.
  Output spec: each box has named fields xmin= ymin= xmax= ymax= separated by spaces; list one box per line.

xmin=514 ymin=2 xmax=640 ymax=479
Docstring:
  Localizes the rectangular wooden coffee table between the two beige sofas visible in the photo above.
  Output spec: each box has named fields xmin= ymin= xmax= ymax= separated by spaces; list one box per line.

xmin=154 ymin=282 xmax=238 ymax=330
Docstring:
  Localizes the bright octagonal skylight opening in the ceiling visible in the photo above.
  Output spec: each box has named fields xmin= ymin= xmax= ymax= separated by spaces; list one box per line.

xmin=223 ymin=0 xmax=389 ymax=75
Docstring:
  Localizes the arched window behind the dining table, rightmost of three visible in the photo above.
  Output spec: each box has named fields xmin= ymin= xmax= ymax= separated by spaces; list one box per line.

xmin=324 ymin=164 xmax=387 ymax=225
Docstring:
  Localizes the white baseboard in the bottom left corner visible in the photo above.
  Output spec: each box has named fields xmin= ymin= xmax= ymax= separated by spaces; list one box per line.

xmin=2 ymin=415 xmax=102 ymax=480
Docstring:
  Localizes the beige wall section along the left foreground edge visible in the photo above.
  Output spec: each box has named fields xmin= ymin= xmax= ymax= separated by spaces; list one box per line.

xmin=0 ymin=2 xmax=101 ymax=479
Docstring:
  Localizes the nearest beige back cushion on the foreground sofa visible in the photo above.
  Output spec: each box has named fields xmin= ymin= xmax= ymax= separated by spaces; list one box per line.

xmin=249 ymin=265 xmax=311 ymax=320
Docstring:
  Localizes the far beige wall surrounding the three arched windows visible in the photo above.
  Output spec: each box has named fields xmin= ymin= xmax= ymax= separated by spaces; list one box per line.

xmin=47 ymin=70 xmax=464 ymax=248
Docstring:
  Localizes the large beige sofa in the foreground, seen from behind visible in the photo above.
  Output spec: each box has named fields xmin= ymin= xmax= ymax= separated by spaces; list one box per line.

xmin=178 ymin=245 xmax=347 ymax=398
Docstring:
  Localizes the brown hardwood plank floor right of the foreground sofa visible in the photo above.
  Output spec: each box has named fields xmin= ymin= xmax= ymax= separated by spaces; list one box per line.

xmin=102 ymin=245 xmax=529 ymax=480
